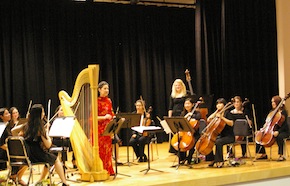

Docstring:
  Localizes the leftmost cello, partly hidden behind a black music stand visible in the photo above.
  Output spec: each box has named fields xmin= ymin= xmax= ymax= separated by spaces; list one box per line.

xmin=171 ymin=101 xmax=200 ymax=152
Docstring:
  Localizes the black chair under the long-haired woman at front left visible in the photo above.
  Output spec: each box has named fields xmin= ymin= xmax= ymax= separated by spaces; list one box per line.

xmin=6 ymin=136 xmax=52 ymax=185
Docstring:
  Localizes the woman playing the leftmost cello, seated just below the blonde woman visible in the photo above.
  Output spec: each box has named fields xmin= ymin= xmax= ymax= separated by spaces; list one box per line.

xmin=179 ymin=98 xmax=201 ymax=165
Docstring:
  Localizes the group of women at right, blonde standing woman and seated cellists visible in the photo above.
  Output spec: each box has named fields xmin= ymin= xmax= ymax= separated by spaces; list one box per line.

xmin=168 ymin=79 xmax=289 ymax=168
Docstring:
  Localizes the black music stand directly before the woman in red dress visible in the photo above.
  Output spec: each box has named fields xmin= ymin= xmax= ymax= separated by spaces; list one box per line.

xmin=102 ymin=118 xmax=131 ymax=179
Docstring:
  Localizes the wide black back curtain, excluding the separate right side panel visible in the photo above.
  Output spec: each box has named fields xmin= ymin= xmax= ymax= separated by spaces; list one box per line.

xmin=0 ymin=0 xmax=195 ymax=142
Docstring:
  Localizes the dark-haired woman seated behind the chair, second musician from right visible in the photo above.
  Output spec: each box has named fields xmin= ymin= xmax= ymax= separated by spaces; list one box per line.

xmin=230 ymin=96 xmax=252 ymax=158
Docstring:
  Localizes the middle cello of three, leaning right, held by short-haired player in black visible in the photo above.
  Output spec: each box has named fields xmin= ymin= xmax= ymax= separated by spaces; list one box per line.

xmin=195 ymin=102 xmax=233 ymax=155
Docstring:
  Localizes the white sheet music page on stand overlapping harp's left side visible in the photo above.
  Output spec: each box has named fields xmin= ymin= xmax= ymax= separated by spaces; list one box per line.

xmin=49 ymin=117 xmax=75 ymax=138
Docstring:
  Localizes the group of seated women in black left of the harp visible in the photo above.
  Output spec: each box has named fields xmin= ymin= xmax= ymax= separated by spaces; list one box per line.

xmin=0 ymin=104 xmax=69 ymax=186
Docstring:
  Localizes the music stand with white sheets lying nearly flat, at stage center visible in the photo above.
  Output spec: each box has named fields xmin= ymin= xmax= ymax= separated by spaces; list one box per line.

xmin=132 ymin=126 xmax=164 ymax=174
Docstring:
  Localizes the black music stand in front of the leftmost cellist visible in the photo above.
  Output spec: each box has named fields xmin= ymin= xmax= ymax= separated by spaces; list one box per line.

xmin=164 ymin=116 xmax=194 ymax=169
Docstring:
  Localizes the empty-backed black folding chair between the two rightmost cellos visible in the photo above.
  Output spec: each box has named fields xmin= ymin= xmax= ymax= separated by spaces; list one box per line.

xmin=228 ymin=119 xmax=254 ymax=164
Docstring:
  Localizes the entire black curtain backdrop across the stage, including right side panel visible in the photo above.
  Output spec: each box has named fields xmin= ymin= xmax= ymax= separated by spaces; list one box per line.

xmin=0 ymin=0 xmax=278 ymax=141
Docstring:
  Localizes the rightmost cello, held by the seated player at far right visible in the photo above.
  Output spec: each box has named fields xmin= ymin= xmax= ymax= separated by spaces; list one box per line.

xmin=255 ymin=93 xmax=290 ymax=147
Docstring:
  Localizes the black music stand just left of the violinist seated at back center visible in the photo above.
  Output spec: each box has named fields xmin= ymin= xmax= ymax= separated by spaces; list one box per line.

xmin=117 ymin=113 xmax=141 ymax=166
